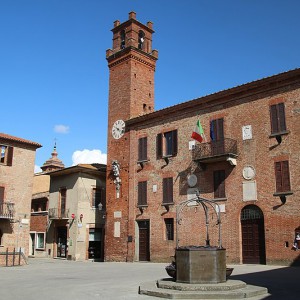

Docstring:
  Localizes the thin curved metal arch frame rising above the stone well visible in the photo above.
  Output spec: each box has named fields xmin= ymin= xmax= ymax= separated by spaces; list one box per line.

xmin=176 ymin=194 xmax=222 ymax=248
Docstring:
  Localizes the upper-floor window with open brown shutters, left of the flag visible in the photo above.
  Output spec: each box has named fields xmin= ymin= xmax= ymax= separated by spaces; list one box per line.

xmin=156 ymin=130 xmax=178 ymax=159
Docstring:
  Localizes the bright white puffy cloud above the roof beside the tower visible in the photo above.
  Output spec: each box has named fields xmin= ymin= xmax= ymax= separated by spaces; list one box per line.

xmin=72 ymin=149 xmax=107 ymax=166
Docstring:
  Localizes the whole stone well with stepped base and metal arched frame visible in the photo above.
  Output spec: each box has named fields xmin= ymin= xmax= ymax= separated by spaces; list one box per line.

xmin=139 ymin=194 xmax=268 ymax=299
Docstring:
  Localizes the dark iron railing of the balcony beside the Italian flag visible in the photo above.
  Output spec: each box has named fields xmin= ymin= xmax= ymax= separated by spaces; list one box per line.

xmin=192 ymin=138 xmax=237 ymax=160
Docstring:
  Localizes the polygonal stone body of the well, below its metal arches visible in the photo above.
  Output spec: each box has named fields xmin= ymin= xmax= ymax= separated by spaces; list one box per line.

xmin=176 ymin=246 xmax=226 ymax=284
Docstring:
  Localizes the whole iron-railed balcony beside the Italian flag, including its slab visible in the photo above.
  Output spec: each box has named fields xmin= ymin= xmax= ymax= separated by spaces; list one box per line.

xmin=192 ymin=138 xmax=238 ymax=165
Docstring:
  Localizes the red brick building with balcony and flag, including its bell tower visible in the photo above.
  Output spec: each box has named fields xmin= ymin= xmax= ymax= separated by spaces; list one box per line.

xmin=105 ymin=12 xmax=300 ymax=264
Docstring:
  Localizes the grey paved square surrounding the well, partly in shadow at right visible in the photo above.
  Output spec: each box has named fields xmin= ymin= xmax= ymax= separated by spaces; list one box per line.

xmin=0 ymin=258 xmax=300 ymax=300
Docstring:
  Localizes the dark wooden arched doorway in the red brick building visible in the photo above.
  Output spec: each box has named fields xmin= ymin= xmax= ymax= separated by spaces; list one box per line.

xmin=241 ymin=205 xmax=266 ymax=264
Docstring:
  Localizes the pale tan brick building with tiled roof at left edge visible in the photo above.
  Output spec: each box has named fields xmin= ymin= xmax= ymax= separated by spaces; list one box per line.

xmin=0 ymin=133 xmax=41 ymax=264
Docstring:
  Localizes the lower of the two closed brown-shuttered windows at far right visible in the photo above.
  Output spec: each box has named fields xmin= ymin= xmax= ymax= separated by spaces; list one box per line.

xmin=275 ymin=160 xmax=291 ymax=193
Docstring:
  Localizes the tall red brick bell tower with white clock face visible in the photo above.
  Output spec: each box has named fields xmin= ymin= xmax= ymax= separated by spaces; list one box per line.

xmin=105 ymin=12 xmax=158 ymax=261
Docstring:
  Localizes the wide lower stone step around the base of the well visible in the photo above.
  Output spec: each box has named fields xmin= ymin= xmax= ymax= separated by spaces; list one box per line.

xmin=139 ymin=281 xmax=268 ymax=299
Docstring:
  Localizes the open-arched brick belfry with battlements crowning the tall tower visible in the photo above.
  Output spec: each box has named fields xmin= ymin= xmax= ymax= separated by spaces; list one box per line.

xmin=106 ymin=11 xmax=158 ymax=60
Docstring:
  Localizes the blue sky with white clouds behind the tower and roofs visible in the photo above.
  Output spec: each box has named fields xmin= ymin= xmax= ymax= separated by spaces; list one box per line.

xmin=0 ymin=0 xmax=300 ymax=171
